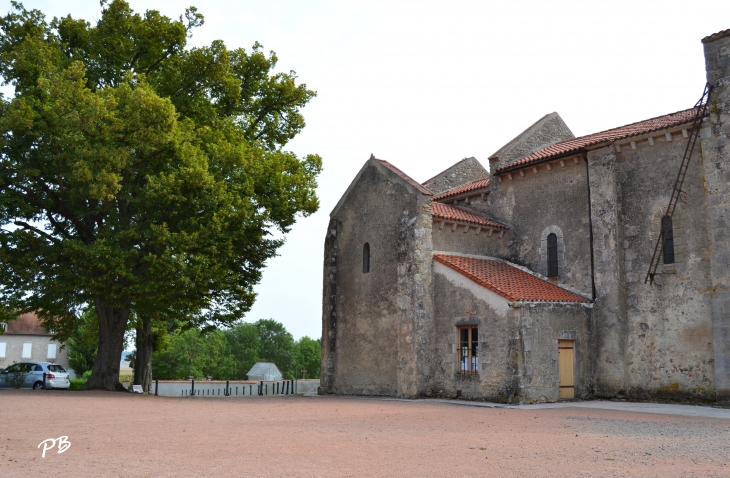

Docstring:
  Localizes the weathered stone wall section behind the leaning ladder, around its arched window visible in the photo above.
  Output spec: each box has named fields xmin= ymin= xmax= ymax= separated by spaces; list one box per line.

xmin=608 ymin=130 xmax=714 ymax=399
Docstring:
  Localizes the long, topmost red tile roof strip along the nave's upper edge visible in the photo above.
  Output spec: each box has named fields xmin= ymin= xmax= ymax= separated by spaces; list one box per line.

xmin=494 ymin=106 xmax=707 ymax=174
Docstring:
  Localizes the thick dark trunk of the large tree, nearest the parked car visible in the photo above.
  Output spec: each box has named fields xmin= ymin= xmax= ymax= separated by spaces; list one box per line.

xmin=84 ymin=300 xmax=129 ymax=390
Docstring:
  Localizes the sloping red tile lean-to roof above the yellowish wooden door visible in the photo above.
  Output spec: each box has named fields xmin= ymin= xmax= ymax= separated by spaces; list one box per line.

xmin=433 ymin=254 xmax=589 ymax=303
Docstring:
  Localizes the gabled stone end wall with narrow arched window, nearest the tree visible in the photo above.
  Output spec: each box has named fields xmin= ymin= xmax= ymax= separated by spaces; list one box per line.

xmin=320 ymin=160 xmax=431 ymax=396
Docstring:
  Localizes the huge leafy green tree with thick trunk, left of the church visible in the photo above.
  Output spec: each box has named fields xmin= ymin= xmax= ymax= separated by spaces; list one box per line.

xmin=0 ymin=0 xmax=321 ymax=389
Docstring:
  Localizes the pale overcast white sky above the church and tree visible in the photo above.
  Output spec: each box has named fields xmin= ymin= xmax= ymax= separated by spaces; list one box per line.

xmin=5 ymin=0 xmax=730 ymax=338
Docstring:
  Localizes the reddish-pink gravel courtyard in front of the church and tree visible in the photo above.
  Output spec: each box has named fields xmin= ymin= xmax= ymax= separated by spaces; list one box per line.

xmin=0 ymin=390 xmax=730 ymax=477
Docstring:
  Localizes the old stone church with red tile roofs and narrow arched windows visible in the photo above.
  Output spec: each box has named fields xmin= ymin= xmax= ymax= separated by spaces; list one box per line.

xmin=320 ymin=30 xmax=730 ymax=403
